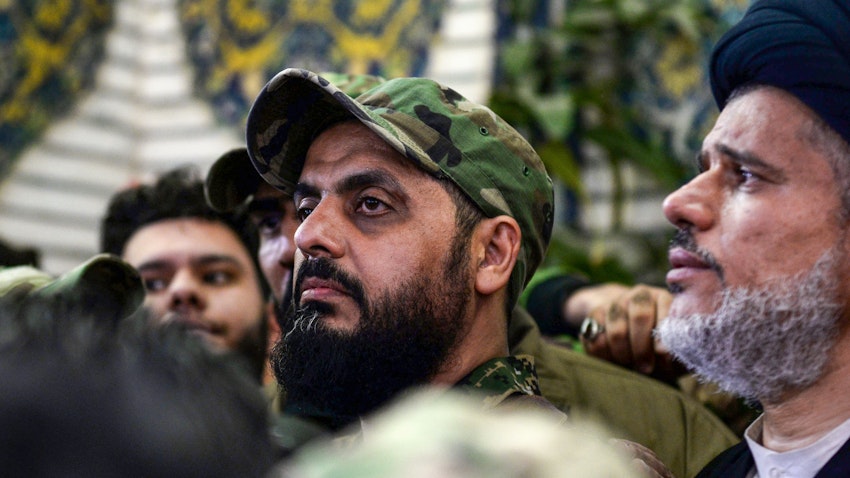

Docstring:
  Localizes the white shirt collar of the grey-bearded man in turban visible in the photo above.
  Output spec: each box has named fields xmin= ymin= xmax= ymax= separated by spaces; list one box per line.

xmin=744 ymin=416 xmax=850 ymax=478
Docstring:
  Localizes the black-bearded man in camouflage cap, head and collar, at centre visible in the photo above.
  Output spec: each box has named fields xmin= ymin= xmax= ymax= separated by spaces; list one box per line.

xmin=242 ymin=69 xmax=563 ymax=425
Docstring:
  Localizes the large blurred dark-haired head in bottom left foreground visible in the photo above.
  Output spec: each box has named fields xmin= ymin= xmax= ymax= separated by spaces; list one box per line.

xmin=0 ymin=291 xmax=280 ymax=477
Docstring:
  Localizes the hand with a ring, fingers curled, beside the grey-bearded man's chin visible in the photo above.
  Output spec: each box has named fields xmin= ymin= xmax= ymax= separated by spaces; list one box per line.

xmin=565 ymin=284 xmax=685 ymax=382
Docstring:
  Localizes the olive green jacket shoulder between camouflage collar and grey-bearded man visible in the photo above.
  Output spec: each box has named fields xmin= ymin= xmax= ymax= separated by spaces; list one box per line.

xmin=508 ymin=307 xmax=739 ymax=478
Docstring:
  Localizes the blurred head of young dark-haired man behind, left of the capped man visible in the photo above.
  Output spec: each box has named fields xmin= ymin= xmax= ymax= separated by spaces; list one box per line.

xmin=101 ymin=168 xmax=272 ymax=382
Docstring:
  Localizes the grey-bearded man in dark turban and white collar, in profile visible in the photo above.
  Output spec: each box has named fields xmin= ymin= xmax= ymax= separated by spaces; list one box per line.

xmin=658 ymin=0 xmax=850 ymax=478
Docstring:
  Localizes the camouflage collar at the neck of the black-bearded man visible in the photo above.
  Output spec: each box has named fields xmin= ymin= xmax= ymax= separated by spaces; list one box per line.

xmin=454 ymin=355 xmax=540 ymax=409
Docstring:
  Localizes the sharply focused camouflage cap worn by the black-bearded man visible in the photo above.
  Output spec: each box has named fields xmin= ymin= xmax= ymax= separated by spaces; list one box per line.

xmin=247 ymin=68 xmax=554 ymax=304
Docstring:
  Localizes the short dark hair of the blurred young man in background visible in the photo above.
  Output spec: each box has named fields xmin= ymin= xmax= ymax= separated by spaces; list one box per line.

xmin=100 ymin=166 xmax=270 ymax=298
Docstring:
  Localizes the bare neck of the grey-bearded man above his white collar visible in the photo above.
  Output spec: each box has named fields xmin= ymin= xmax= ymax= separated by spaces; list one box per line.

xmin=762 ymin=334 xmax=850 ymax=452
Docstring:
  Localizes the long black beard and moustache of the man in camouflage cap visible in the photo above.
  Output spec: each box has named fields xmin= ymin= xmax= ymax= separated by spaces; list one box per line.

xmin=272 ymin=243 xmax=472 ymax=428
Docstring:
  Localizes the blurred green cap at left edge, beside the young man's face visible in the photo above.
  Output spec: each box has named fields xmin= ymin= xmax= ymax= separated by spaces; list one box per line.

xmin=0 ymin=254 xmax=145 ymax=318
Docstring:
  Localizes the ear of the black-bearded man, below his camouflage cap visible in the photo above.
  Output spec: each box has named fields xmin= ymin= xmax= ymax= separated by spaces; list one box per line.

xmin=475 ymin=216 xmax=522 ymax=295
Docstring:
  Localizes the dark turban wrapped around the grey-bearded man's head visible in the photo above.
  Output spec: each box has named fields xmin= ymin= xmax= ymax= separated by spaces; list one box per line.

xmin=711 ymin=0 xmax=850 ymax=143
